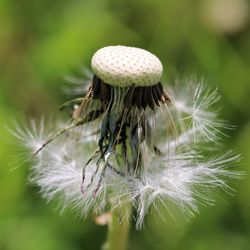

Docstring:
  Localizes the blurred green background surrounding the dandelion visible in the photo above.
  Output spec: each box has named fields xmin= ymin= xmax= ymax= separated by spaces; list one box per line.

xmin=0 ymin=0 xmax=250 ymax=250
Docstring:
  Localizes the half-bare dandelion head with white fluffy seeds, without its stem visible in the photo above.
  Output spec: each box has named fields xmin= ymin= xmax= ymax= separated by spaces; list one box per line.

xmin=16 ymin=46 xmax=239 ymax=250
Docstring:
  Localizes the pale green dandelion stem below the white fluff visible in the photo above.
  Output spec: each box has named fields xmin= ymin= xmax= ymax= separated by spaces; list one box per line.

xmin=104 ymin=205 xmax=131 ymax=250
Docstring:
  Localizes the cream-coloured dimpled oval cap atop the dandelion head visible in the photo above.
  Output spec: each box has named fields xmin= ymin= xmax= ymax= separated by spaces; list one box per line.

xmin=91 ymin=45 xmax=163 ymax=87
